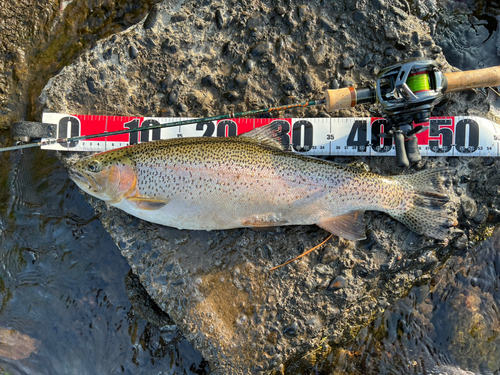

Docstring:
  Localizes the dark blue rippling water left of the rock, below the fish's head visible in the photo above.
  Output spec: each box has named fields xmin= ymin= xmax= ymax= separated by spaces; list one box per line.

xmin=0 ymin=134 xmax=206 ymax=375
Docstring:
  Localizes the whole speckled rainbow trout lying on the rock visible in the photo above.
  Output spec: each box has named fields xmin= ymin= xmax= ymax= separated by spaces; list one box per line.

xmin=70 ymin=124 xmax=454 ymax=240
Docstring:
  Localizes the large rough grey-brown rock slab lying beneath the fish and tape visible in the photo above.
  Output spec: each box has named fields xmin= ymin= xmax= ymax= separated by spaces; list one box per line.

xmin=40 ymin=0 xmax=500 ymax=374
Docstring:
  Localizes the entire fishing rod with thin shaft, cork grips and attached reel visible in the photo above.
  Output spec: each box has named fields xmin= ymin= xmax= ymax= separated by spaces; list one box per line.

xmin=0 ymin=59 xmax=500 ymax=167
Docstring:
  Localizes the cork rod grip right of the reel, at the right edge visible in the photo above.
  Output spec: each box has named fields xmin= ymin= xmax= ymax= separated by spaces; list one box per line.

xmin=444 ymin=66 xmax=500 ymax=93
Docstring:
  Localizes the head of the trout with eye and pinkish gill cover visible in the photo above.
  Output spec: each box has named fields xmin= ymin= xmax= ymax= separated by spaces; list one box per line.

xmin=69 ymin=152 xmax=137 ymax=203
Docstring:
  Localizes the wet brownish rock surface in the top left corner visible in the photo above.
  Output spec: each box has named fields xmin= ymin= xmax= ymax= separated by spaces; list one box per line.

xmin=0 ymin=0 xmax=159 ymax=129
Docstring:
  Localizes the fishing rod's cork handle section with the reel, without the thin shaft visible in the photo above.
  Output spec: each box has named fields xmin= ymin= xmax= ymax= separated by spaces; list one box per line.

xmin=325 ymin=58 xmax=500 ymax=167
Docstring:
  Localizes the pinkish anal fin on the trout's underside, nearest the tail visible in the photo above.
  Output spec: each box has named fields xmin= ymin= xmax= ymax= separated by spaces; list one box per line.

xmin=316 ymin=211 xmax=366 ymax=241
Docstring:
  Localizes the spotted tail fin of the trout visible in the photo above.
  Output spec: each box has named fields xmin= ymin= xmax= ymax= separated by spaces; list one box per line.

xmin=390 ymin=167 xmax=456 ymax=240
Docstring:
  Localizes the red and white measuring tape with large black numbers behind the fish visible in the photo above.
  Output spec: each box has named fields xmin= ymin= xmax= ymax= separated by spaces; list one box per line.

xmin=42 ymin=113 xmax=500 ymax=157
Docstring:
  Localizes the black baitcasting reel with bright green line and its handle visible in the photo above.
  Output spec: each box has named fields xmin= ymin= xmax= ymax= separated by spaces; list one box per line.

xmin=376 ymin=59 xmax=447 ymax=167
